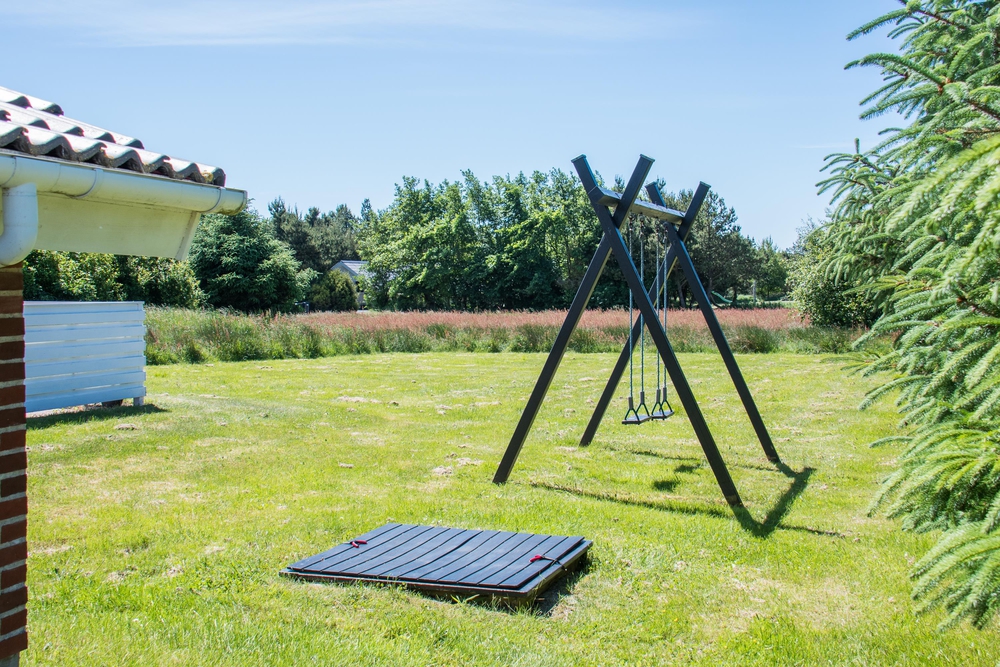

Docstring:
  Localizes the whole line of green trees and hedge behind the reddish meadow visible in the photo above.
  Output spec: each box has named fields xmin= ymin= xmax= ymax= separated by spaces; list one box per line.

xmin=25 ymin=169 xmax=787 ymax=312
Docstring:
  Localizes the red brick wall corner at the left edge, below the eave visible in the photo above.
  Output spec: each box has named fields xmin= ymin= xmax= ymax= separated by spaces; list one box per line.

xmin=0 ymin=264 xmax=28 ymax=667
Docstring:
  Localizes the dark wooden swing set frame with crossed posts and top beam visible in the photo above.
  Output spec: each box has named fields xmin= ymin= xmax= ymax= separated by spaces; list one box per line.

xmin=493 ymin=155 xmax=779 ymax=506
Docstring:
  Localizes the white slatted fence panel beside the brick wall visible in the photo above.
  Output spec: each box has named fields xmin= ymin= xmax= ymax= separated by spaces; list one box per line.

xmin=24 ymin=301 xmax=146 ymax=412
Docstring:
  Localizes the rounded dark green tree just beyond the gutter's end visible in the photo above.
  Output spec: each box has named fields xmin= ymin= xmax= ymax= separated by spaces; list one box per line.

xmin=190 ymin=210 xmax=316 ymax=312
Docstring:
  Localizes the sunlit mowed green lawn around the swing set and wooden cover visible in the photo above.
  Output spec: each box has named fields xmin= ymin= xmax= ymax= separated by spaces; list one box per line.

xmin=26 ymin=353 xmax=1000 ymax=666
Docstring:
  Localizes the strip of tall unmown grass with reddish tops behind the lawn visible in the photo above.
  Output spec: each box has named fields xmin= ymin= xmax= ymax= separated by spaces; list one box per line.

xmin=146 ymin=307 xmax=861 ymax=364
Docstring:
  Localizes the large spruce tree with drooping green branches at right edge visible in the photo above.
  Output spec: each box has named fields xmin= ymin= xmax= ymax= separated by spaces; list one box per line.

xmin=816 ymin=0 xmax=1000 ymax=627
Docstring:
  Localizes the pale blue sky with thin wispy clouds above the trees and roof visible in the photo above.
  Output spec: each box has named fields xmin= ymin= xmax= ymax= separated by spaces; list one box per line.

xmin=0 ymin=0 xmax=898 ymax=246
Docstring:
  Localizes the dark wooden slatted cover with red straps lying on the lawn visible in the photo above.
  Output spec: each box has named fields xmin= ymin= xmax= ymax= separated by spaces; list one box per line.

xmin=281 ymin=523 xmax=592 ymax=604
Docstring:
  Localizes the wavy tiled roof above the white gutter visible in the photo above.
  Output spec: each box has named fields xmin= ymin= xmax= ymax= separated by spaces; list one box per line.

xmin=0 ymin=87 xmax=226 ymax=186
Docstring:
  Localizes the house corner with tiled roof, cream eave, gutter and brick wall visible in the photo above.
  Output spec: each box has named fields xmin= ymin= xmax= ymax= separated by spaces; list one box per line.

xmin=0 ymin=88 xmax=247 ymax=667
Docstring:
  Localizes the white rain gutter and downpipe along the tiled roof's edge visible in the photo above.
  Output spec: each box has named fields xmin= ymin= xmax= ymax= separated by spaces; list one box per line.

xmin=0 ymin=151 xmax=247 ymax=266
